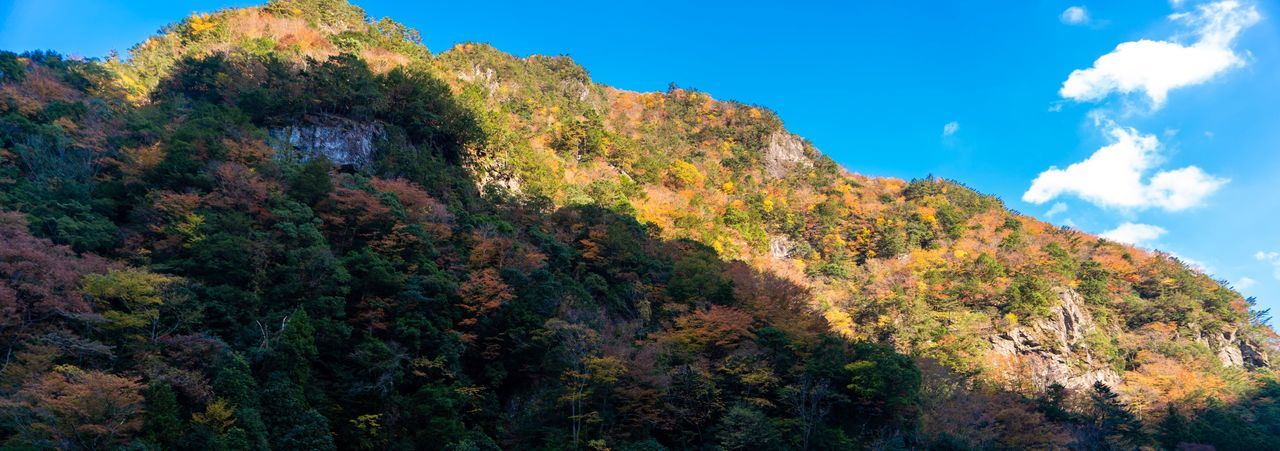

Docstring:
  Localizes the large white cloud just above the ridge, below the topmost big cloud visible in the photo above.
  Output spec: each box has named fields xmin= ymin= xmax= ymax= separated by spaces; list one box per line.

xmin=1023 ymin=123 xmax=1229 ymax=211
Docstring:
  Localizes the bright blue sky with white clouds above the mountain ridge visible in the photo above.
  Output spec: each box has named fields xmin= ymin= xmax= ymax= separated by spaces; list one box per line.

xmin=0 ymin=0 xmax=1280 ymax=311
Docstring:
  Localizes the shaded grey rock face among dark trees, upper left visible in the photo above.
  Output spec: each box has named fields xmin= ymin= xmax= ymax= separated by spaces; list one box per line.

xmin=269 ymin=118 xmax=387 ymax=169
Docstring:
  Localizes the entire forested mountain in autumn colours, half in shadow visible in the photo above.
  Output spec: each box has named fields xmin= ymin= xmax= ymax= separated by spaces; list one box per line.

xmin=0 ymin=0 xmax=1280 ymax=450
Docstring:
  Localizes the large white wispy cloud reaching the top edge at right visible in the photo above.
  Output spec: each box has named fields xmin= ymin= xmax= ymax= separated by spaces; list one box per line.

xmin=1059 ymin=0 xmax=1262 ymax=109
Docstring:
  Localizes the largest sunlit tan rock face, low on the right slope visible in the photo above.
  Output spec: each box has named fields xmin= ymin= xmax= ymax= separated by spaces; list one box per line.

xmin=991 ymin=288 xmax=1120 ymax=390
